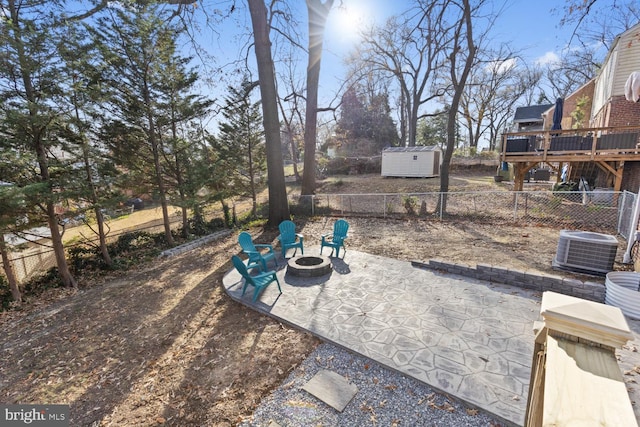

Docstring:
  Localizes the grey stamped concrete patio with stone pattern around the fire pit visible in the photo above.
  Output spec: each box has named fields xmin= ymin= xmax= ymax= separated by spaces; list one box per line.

xmin=224 ymin=247 xmax=640 ymax=425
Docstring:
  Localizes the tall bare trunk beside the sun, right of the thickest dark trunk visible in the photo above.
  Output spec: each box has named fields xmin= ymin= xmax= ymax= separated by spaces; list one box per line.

xmin=300 ymin=0 xmax=333 ymax=196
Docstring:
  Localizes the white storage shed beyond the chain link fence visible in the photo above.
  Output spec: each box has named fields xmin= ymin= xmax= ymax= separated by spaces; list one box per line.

xmin=382 ymin=145 xmax=442 ymax=178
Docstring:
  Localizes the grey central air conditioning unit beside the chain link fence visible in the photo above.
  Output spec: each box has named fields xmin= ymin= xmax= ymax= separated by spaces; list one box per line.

xmin=553 ymin=230 xmax=618 ymax=276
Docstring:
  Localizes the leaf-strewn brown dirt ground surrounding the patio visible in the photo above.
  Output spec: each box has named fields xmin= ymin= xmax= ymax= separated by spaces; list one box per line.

xmin=0 ymin=172 xmax=624 ymax=426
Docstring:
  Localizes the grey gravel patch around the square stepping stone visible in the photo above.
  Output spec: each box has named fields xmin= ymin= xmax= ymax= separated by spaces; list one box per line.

xmin=239 ymin=343 xmax=503 ymax=427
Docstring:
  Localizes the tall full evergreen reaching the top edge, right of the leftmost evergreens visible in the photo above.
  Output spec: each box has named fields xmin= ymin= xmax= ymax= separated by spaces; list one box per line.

xmin=93 ymin=4 xmax=194 ymax=245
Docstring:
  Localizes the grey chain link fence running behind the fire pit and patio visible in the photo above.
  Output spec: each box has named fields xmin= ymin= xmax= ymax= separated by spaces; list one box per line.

xmin=289 ymin=191 xmax=636 ymax=239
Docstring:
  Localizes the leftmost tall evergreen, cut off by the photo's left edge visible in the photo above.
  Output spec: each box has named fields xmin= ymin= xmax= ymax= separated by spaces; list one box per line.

xmin=0 ymin=0 xmax=76 ymax=287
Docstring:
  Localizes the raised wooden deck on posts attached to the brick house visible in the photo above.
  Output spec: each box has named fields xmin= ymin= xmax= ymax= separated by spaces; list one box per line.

xmin=501 ymin=126 xmax=640 ymax=191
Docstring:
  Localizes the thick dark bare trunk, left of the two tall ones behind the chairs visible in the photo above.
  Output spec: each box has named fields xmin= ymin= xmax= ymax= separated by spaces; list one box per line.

xmin=247 ymin=0 xmax=289 ymax=226
